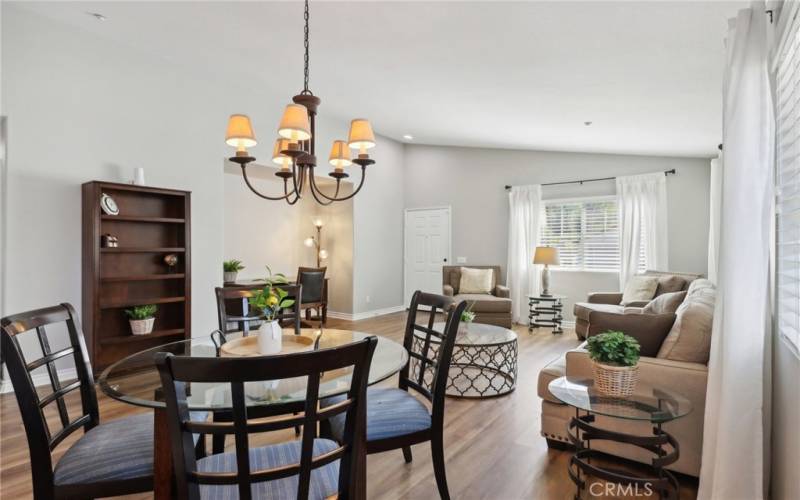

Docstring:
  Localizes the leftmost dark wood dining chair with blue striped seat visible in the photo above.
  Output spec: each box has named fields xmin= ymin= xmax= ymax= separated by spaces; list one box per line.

xmin=0 ymin=304 xmax=156 ymax=499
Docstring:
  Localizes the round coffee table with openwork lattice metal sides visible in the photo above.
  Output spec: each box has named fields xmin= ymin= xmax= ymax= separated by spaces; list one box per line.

xmin=411 ymin=323 xmax=517 ymax=398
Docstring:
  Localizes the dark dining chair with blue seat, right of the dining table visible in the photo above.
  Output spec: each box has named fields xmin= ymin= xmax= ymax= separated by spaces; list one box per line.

xmin=322 ymin=291 xmax=467 ymax=499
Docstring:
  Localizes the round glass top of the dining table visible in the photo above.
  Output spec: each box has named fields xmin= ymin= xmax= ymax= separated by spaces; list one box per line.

xmin=98 ymin=328 xmax=408 ymax=410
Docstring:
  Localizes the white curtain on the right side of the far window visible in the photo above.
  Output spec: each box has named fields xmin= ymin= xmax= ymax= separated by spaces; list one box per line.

xmin=617 ymin=172 xmax=669 ymax=290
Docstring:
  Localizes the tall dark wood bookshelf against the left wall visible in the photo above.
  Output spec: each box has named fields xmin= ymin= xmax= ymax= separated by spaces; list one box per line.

xmin=82 ymin=181 xmax=191 ymax=375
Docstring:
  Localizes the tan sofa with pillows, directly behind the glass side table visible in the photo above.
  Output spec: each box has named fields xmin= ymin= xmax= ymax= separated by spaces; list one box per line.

xmin=537 ymin=279 xmax=716 ymax=477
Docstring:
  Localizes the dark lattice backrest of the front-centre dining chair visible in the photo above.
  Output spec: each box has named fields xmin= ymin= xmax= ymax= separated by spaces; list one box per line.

xmin=156 ymin=337 xmax=377 ymax=499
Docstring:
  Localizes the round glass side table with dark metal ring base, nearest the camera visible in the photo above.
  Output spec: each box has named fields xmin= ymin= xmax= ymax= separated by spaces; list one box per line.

xmin=548 ymin=377 xmax=692 ymax=500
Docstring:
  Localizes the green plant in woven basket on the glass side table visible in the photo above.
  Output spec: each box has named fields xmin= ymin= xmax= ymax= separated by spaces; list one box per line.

xmin=586 ymin=331 xmax=639 ymax=396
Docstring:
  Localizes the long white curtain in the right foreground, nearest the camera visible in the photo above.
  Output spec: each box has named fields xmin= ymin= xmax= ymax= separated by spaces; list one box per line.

xmin=698 ymin=2 xmax=775 ymax=499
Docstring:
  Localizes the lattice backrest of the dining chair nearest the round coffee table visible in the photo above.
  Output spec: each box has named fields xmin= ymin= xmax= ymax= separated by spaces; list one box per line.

xmin=400 ymin=291 xmax=467 ymax=408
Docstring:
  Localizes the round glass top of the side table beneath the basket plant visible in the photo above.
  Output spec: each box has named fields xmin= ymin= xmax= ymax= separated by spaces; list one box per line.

xmin=548 ymin=377 xmax=692 ymax=423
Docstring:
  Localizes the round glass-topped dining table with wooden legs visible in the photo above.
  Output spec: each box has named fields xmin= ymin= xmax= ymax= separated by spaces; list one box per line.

xmin=98 ymin=329 xmax=408 ymax=500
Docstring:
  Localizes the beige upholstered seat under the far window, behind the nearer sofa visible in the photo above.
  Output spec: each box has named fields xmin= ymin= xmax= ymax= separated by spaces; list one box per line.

xmin=572 ymin=271 xmax=702 ymax=340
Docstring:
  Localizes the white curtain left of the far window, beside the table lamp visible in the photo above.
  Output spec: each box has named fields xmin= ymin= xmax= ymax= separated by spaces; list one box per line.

xmin=506 ymin=184 xmax=542 ymax=323
